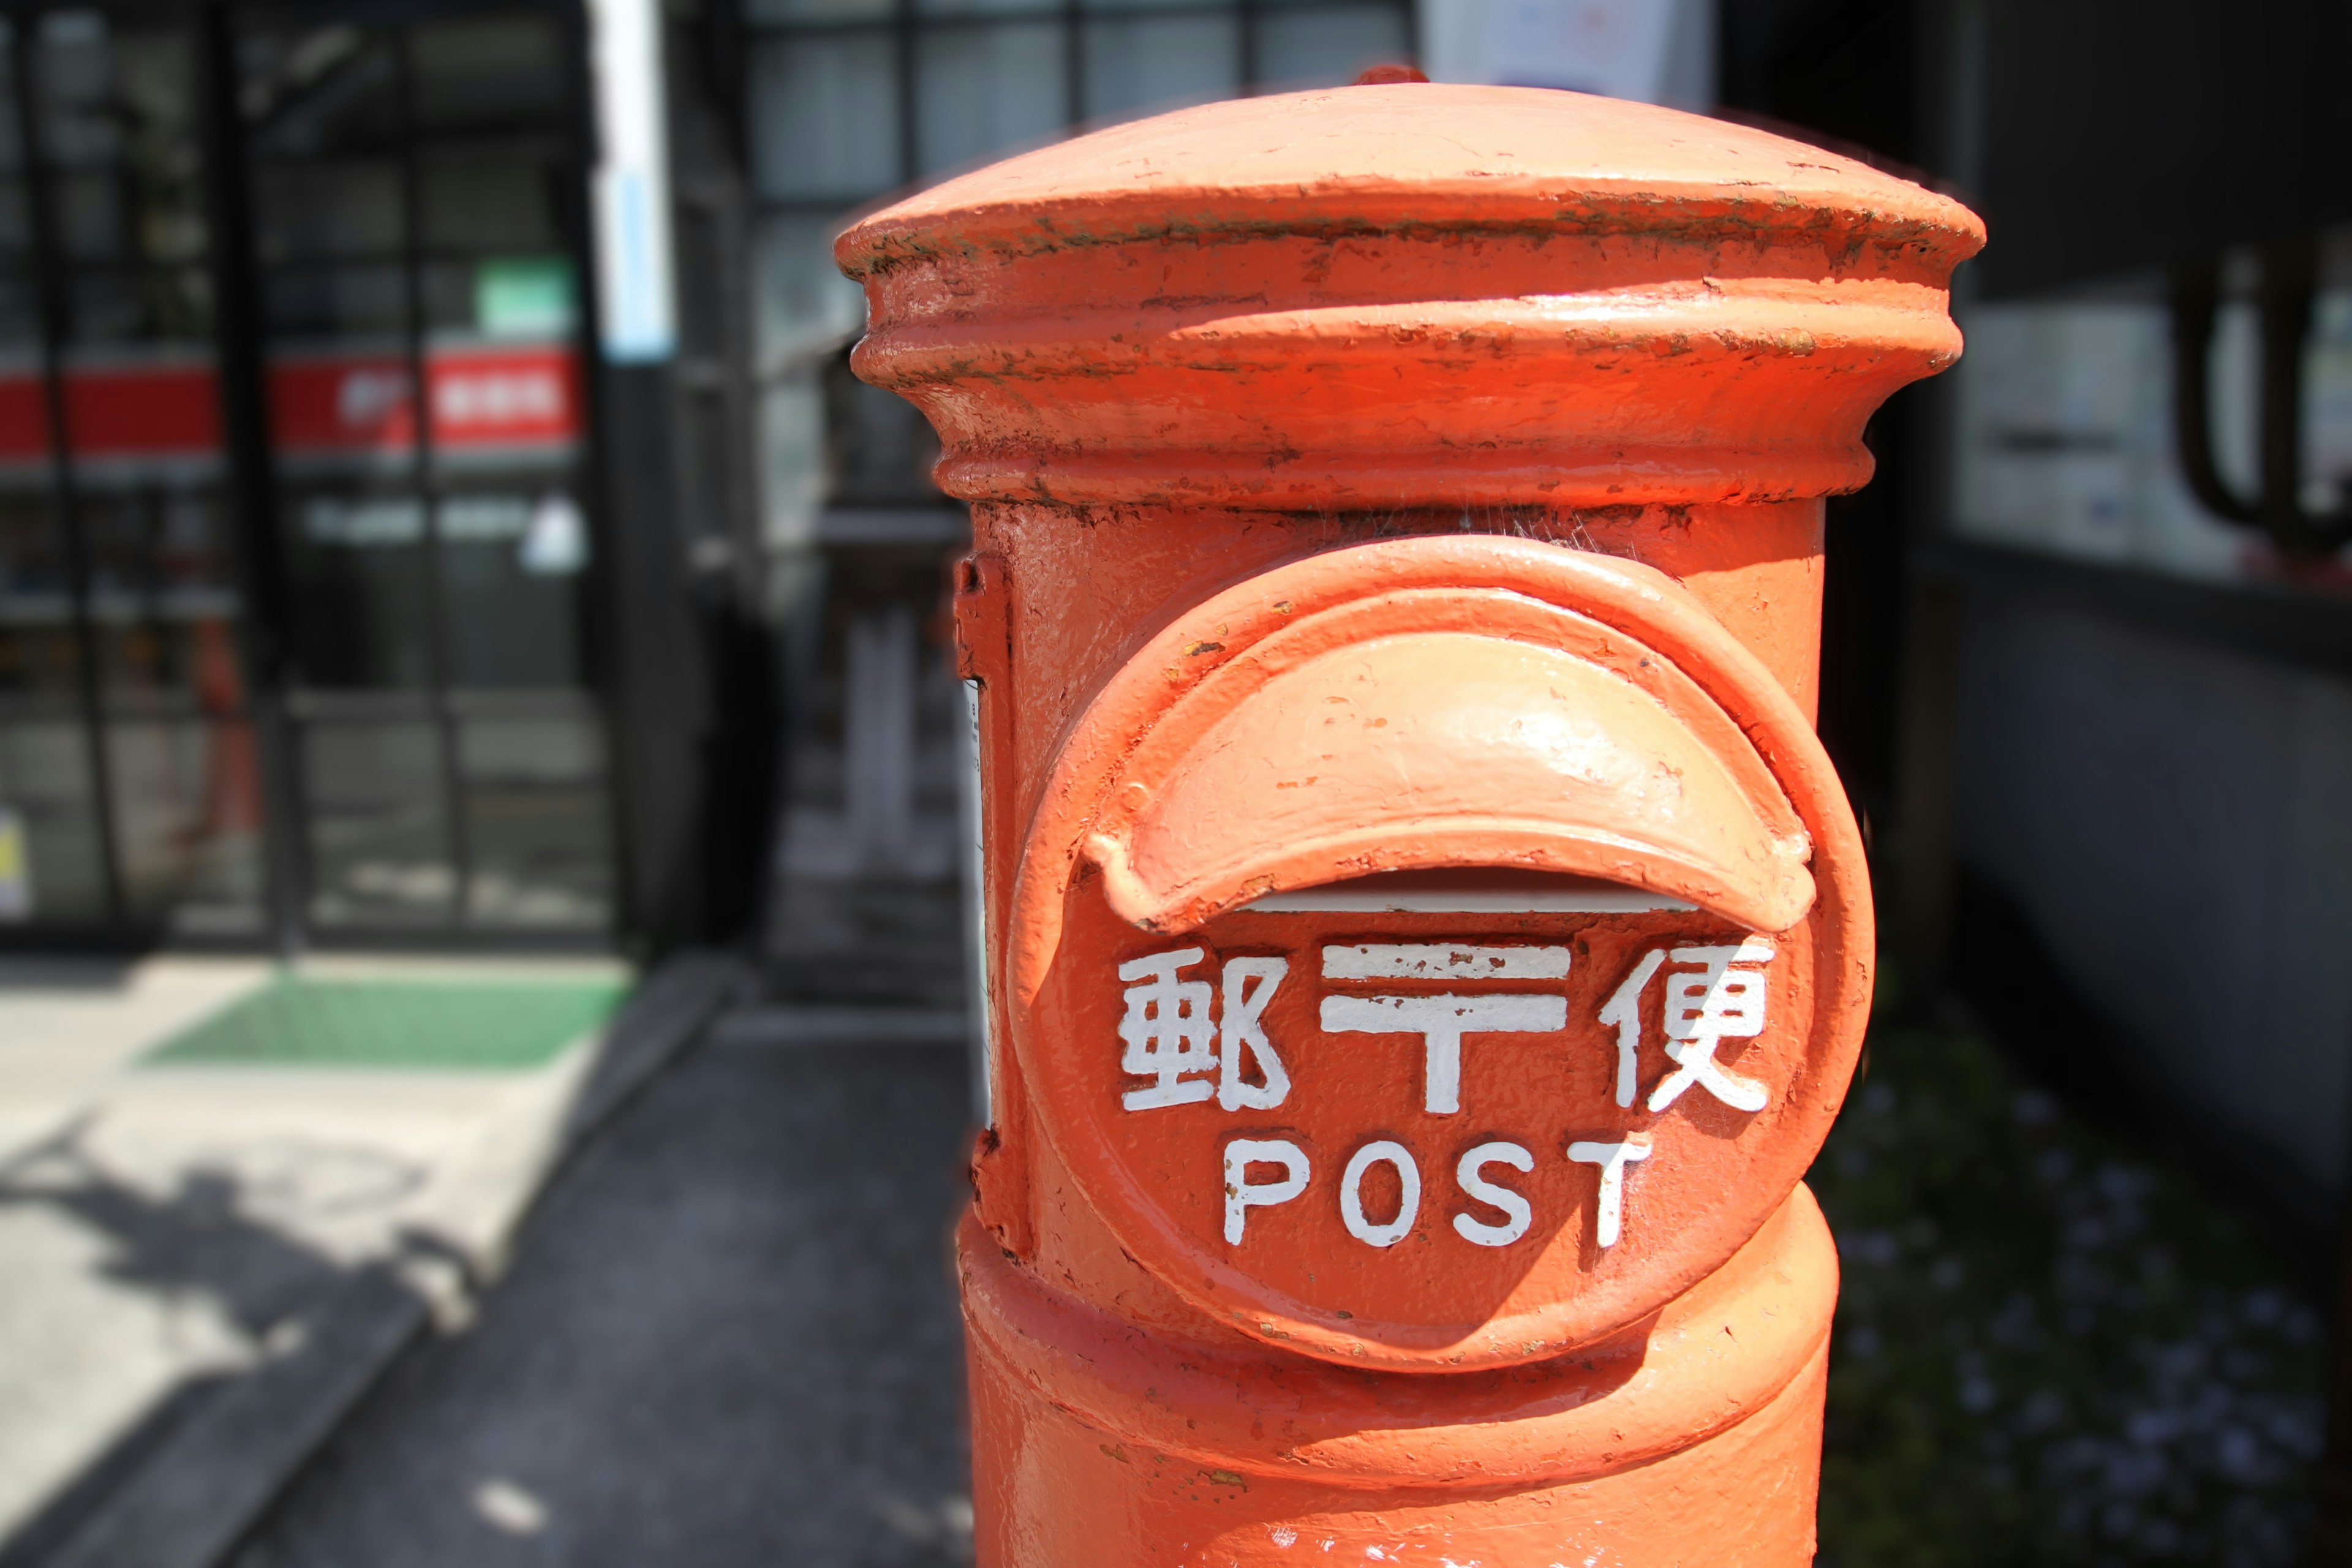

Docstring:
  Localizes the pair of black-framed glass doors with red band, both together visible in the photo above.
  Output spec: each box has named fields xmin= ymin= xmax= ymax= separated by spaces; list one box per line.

xmin=0 ymin=7 xmax=616 ymax=943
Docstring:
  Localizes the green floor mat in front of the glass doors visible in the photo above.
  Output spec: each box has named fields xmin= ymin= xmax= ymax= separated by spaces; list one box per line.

xmin=148 ymin=980 xmax=625 ymax=1069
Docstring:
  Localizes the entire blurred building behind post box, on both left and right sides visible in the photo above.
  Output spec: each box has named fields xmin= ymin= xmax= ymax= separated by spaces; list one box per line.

xmin=0 ymin=0 xmax=2352 ymax=1232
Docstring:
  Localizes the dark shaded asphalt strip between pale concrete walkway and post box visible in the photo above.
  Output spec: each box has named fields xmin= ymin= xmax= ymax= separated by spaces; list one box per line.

xmin=235 ymin=1027 xmax=971 ymax=1568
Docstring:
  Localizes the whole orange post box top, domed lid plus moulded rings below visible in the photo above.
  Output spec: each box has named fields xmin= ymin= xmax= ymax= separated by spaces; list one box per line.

xmin=835 ymin=82 xmax=1983 ymax=510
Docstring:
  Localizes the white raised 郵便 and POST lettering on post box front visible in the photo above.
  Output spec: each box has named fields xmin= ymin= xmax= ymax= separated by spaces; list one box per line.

xmin=1117 ymin=938 xmax=1776 ymax=1251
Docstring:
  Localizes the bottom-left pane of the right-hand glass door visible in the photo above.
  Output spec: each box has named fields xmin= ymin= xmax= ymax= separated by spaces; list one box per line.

xmin=301 ymin=724 xmax=456 ymax=926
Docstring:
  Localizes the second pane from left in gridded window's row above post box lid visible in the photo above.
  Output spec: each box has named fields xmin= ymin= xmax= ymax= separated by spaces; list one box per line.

xmin=915 ymin=21 xmax=1070 ymax=174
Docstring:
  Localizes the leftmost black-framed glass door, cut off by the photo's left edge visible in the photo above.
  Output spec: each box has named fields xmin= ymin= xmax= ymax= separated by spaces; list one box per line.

xmin=0 ymin=9 xmax=263 ymax=936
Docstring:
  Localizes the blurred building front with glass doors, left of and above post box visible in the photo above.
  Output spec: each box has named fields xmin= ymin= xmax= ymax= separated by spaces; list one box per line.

xmin=0 ymin=0 xmax=1713 ymax=968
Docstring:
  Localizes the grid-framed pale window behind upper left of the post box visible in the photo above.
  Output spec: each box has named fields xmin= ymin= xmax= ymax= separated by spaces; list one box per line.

xmin=745 ymin=0 xmax=1411 ymax=548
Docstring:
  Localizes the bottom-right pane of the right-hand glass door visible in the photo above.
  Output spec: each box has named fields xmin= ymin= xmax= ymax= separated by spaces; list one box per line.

xmin=459 ymin=717 xmax=611 ymax=931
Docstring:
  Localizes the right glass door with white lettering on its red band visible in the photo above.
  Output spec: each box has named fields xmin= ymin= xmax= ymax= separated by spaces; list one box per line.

xmin=238 ymin=12 xmax=614 ymax=933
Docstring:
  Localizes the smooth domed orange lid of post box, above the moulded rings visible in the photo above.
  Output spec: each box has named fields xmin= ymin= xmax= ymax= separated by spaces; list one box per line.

xmin=837 ymin=82 xmax=1985 ymax=277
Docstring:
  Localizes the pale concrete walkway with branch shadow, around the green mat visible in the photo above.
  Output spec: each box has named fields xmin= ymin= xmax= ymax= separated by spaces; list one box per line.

xmin=0 ymin=957 xmax=741 ymax=1568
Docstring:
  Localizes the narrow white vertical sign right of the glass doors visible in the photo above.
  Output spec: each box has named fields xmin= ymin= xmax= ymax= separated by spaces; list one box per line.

xmin=588 ymin=0 xmax=677 ymax=364
